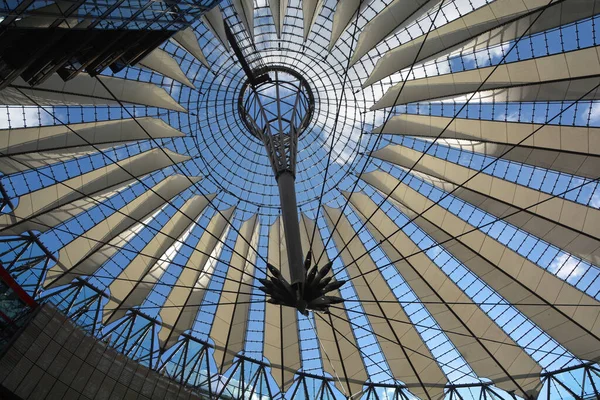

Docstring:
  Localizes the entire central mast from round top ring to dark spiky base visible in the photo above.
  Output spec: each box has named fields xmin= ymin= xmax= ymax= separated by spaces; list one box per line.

xmin=238 ymin=67 xmax=344 ymax=314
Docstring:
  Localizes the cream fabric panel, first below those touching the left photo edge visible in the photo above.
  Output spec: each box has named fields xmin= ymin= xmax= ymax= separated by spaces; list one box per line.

xmin=44 ymin=175 xmax=203 ymax=287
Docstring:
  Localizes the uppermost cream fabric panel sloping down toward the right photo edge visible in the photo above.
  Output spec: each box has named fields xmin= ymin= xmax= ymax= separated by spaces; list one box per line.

xmin=373 ymin=114 xmax=600 ymax=179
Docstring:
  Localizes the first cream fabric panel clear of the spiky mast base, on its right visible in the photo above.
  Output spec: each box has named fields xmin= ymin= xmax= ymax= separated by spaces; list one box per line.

xmin=324 ymin=206 xmax=447 ymax=399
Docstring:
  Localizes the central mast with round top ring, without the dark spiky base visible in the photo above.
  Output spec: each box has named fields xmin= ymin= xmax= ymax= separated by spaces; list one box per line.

xmin=239 ymin=67 xmax=314 ymax=291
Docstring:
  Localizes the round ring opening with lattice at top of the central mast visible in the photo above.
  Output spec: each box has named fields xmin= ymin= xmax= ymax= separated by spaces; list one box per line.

xmin=238 ymin=67 xmax=315 ymax=139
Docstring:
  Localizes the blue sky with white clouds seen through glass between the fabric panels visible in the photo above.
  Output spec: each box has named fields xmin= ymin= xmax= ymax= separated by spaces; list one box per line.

xmin=0 ymin=0 xmax=600 ymax=398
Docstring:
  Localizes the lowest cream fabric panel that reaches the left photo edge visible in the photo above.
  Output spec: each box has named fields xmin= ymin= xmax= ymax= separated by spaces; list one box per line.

xmin=0 ymin=149 xmax=189 ymax=234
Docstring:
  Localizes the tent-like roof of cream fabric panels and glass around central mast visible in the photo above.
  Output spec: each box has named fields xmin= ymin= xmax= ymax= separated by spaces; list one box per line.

xmin=0 ymin=0 xmax=600 ymax=400
